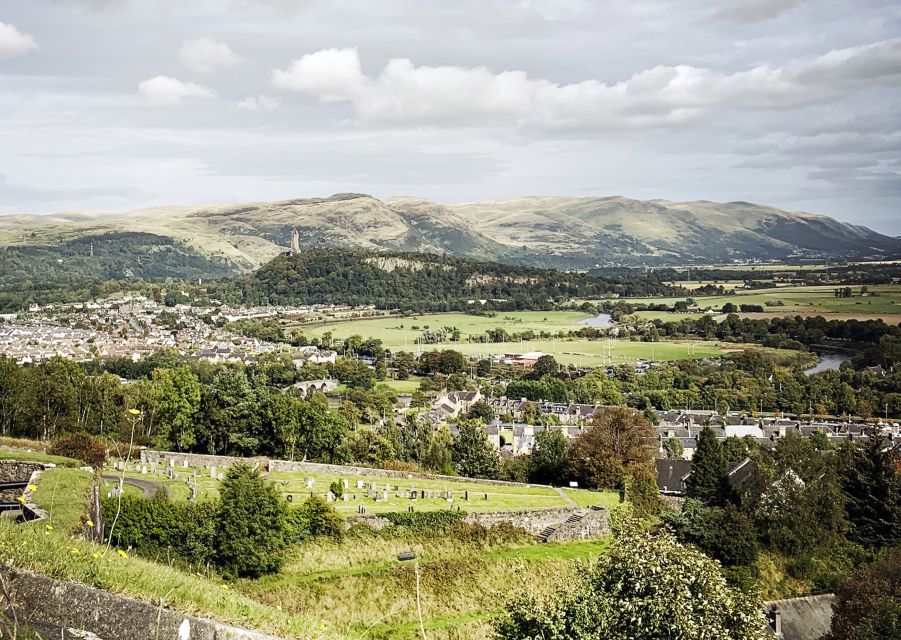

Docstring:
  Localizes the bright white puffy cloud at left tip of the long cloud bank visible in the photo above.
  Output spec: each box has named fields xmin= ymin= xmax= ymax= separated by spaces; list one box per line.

xmin=272 ymin=49 xmax=367 ymax=102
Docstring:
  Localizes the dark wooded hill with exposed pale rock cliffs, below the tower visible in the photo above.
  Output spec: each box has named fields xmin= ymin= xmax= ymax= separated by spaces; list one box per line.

xmin=204 ymin=249 xmax=681 ymax=311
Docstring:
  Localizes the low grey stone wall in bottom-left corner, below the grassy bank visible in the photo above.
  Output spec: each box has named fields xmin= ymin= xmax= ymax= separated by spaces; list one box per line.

xmin=0 ymin=565 xmax=278 ymax=640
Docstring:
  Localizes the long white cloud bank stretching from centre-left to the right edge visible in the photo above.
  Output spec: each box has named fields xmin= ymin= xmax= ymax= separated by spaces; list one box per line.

xmin=272 ymin=39 xmax=901 ymax=128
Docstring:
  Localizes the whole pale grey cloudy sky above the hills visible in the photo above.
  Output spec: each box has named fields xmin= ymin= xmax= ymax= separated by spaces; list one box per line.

xmin=0 ymin=0 xmax=901 ymax=234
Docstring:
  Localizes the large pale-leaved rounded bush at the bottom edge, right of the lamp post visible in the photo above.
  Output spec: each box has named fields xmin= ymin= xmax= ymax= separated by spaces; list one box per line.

xmin=495 ymin=522 xmax=765 ymax=640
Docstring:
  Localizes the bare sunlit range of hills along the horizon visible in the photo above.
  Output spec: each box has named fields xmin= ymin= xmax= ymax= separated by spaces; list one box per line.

xmin=0 ymin=193 xmax=901 ymax=271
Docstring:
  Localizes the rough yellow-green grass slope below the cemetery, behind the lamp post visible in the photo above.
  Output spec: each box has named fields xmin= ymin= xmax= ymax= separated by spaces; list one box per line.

xmin=239 ymin=535 xmax=608 ymax=640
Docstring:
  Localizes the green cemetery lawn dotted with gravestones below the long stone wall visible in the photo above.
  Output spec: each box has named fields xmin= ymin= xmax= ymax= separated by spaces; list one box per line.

xmin=103 ymin=460 xmax=619 ymax=515
